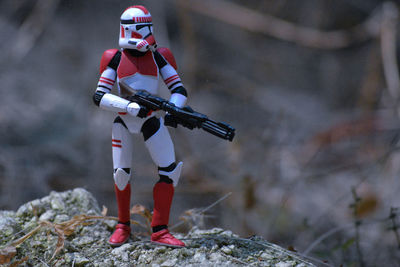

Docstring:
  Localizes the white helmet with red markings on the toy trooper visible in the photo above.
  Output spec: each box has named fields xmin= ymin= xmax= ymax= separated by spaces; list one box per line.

xmin=119 ymin=6 xmax=155 ymax=52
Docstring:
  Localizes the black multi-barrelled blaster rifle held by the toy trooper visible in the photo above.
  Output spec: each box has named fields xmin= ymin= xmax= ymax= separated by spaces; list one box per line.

xmin=119 ymin=82 xmax=235 ymax=141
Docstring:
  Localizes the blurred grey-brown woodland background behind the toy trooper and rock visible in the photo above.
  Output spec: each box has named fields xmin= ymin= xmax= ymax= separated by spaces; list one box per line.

xmin=0 ymin=0 xmax=400 ymax=266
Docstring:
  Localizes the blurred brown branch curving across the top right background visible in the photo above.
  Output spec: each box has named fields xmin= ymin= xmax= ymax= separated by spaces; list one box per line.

xmin=181 ymin=0 xmax=381 ymax=49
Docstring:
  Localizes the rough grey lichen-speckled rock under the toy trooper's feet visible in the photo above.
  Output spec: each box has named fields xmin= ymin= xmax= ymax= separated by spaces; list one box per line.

xmin=0 ymin=188 xmax=314 ymax=267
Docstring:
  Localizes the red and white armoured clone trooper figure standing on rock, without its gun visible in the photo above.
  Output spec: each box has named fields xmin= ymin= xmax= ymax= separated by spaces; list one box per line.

xmin=93 ymin=6 xmax=187 ymax=247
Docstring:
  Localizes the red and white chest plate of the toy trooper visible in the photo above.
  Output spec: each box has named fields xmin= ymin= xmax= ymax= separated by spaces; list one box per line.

xmin=117 ymin=51 xmax=158 ymax=96
